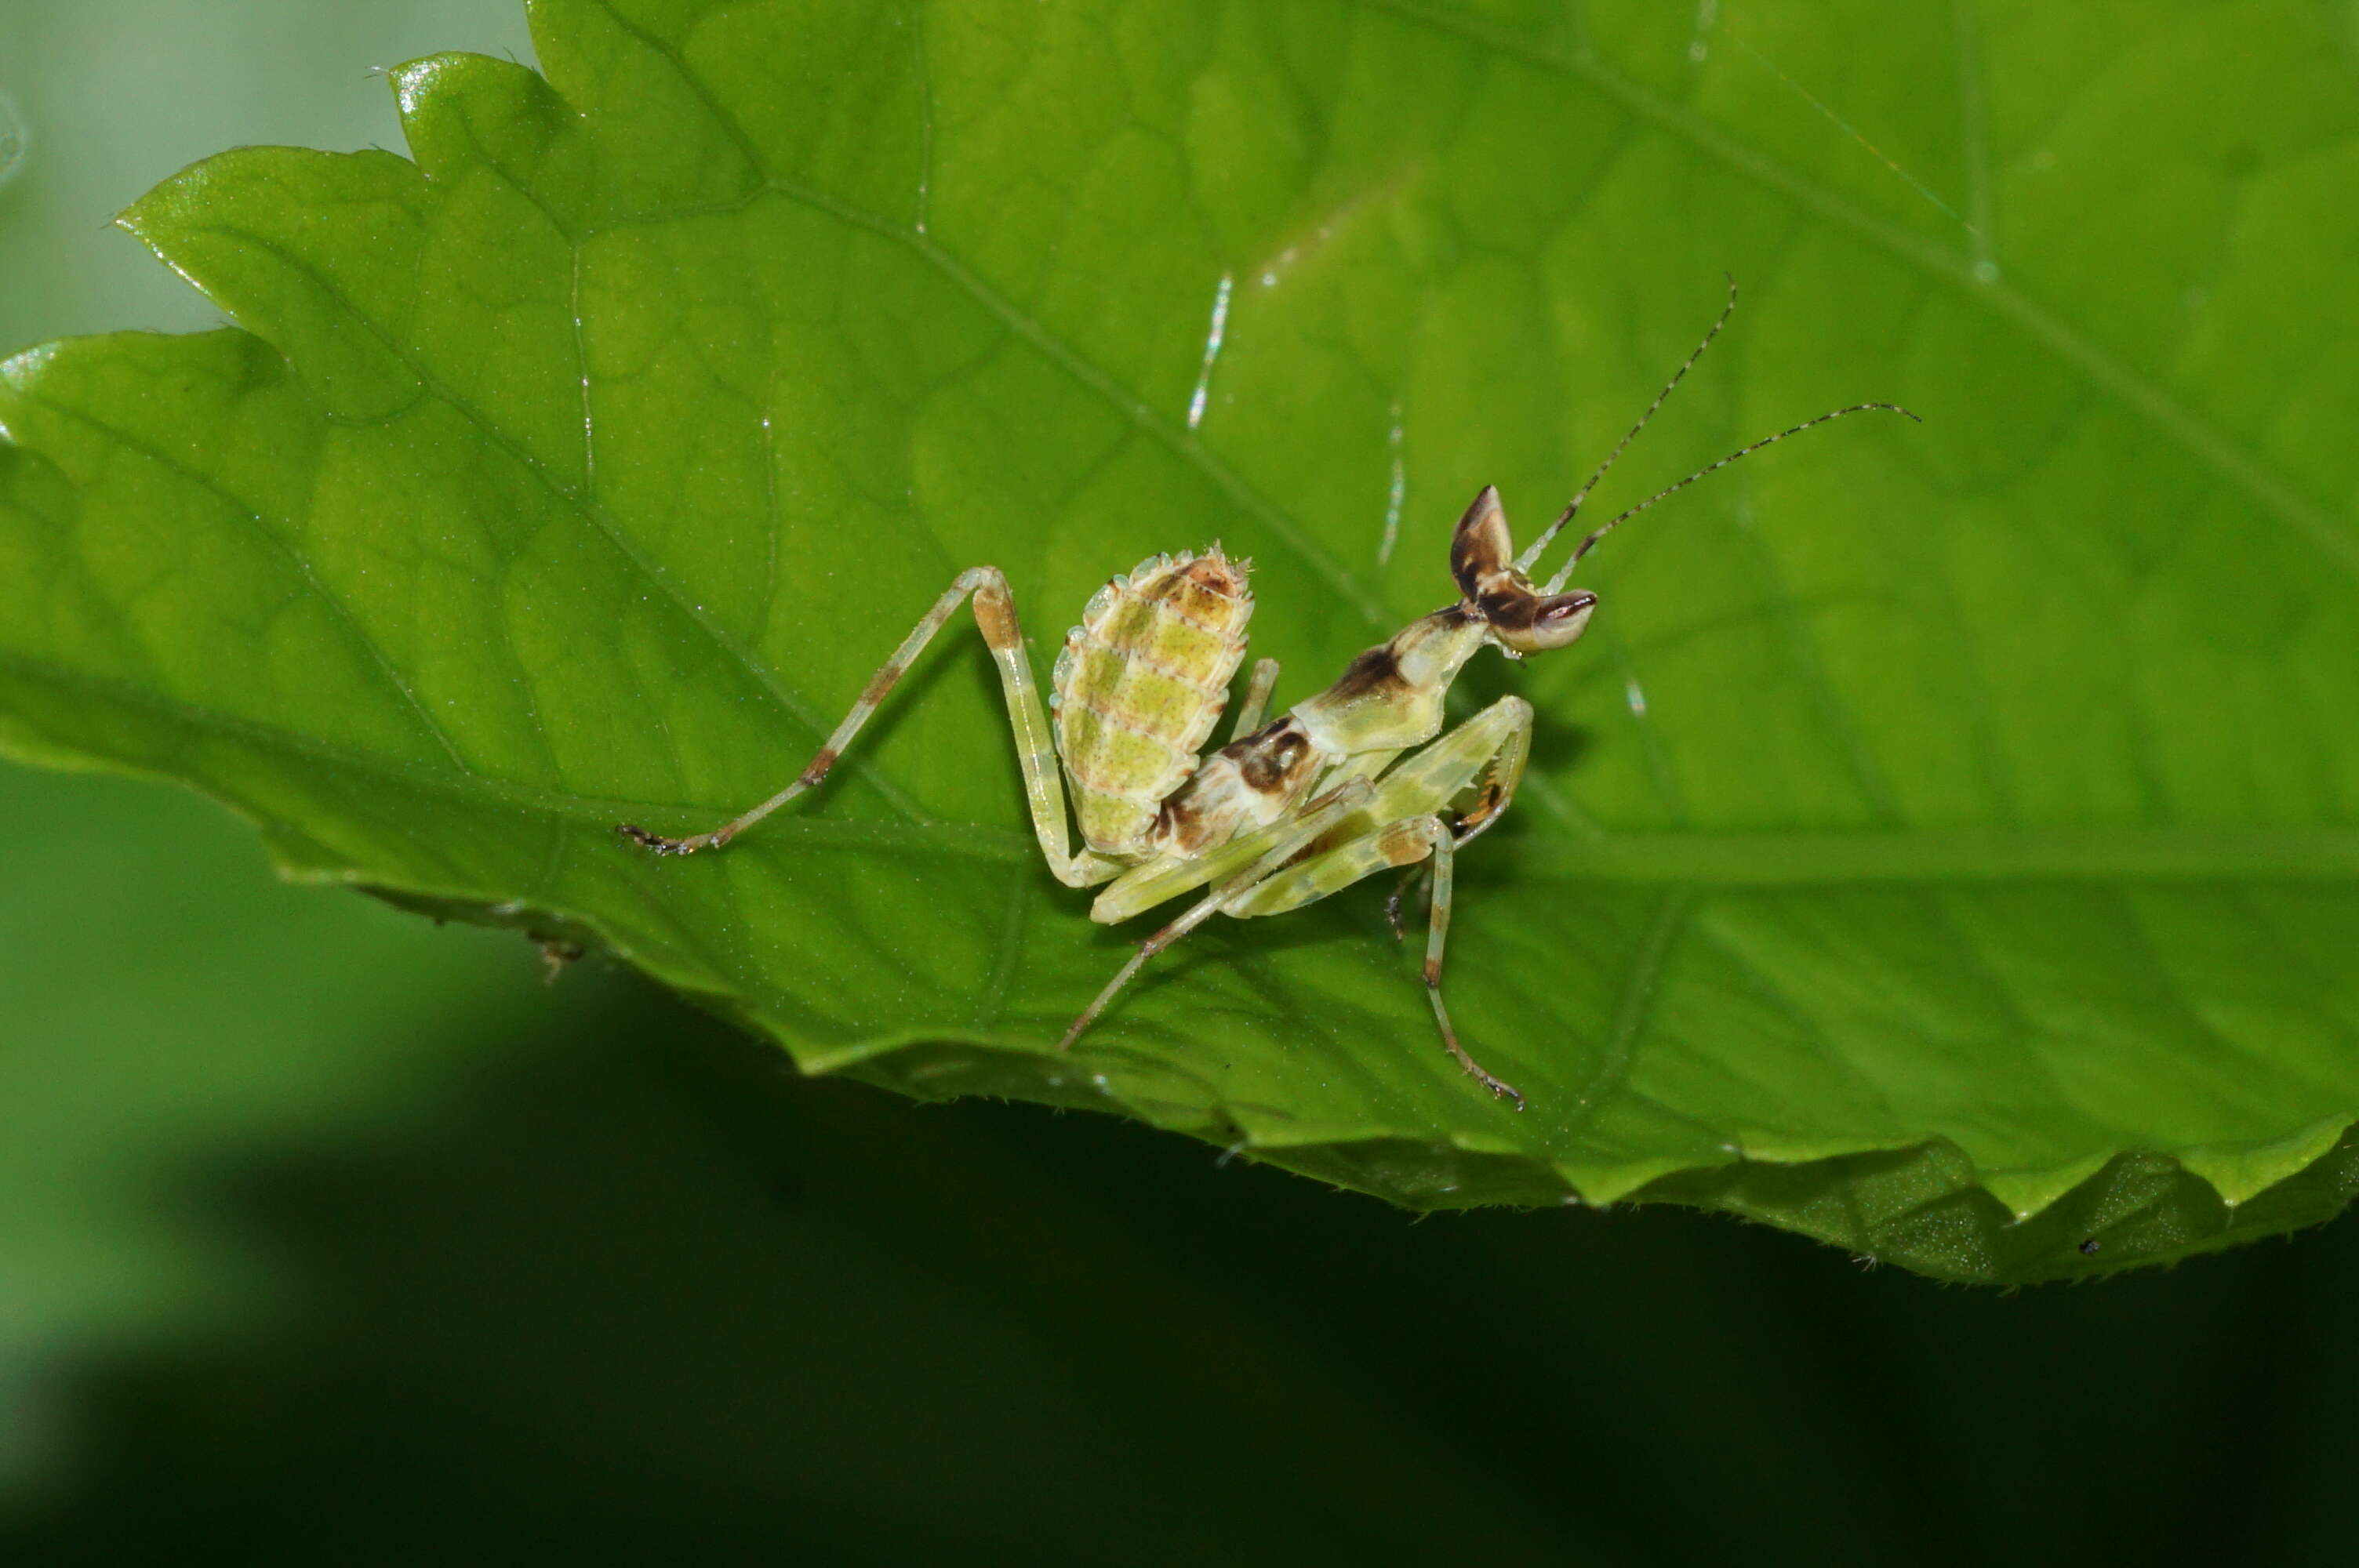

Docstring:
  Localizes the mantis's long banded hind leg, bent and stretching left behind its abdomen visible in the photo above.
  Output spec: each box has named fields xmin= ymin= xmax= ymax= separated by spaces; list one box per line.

xmin=618 ymin=566 xmax=1123 ymax=887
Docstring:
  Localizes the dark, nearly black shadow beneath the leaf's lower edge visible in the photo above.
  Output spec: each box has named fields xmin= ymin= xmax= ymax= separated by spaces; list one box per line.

xmin=0 ymin=976 xmax=2359 ymax=1566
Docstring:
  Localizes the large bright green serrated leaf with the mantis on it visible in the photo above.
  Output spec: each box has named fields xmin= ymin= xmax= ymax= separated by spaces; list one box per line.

xmin=0 ymin=0 xmax=2359 ymax=1280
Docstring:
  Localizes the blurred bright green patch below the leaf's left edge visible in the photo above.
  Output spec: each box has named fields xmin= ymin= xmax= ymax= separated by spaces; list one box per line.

xmin=0 ymin=766 xmax=535 ymax=1367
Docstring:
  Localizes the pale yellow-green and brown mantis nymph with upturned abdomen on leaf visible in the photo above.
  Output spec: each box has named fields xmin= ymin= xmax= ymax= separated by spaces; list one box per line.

xmin=616 ymin=281 xmax=1915 ymax=1109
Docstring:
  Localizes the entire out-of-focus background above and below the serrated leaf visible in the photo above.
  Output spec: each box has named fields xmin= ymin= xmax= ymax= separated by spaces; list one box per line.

xmin=0 ymin=0 xmax=2359 ymax=1563
